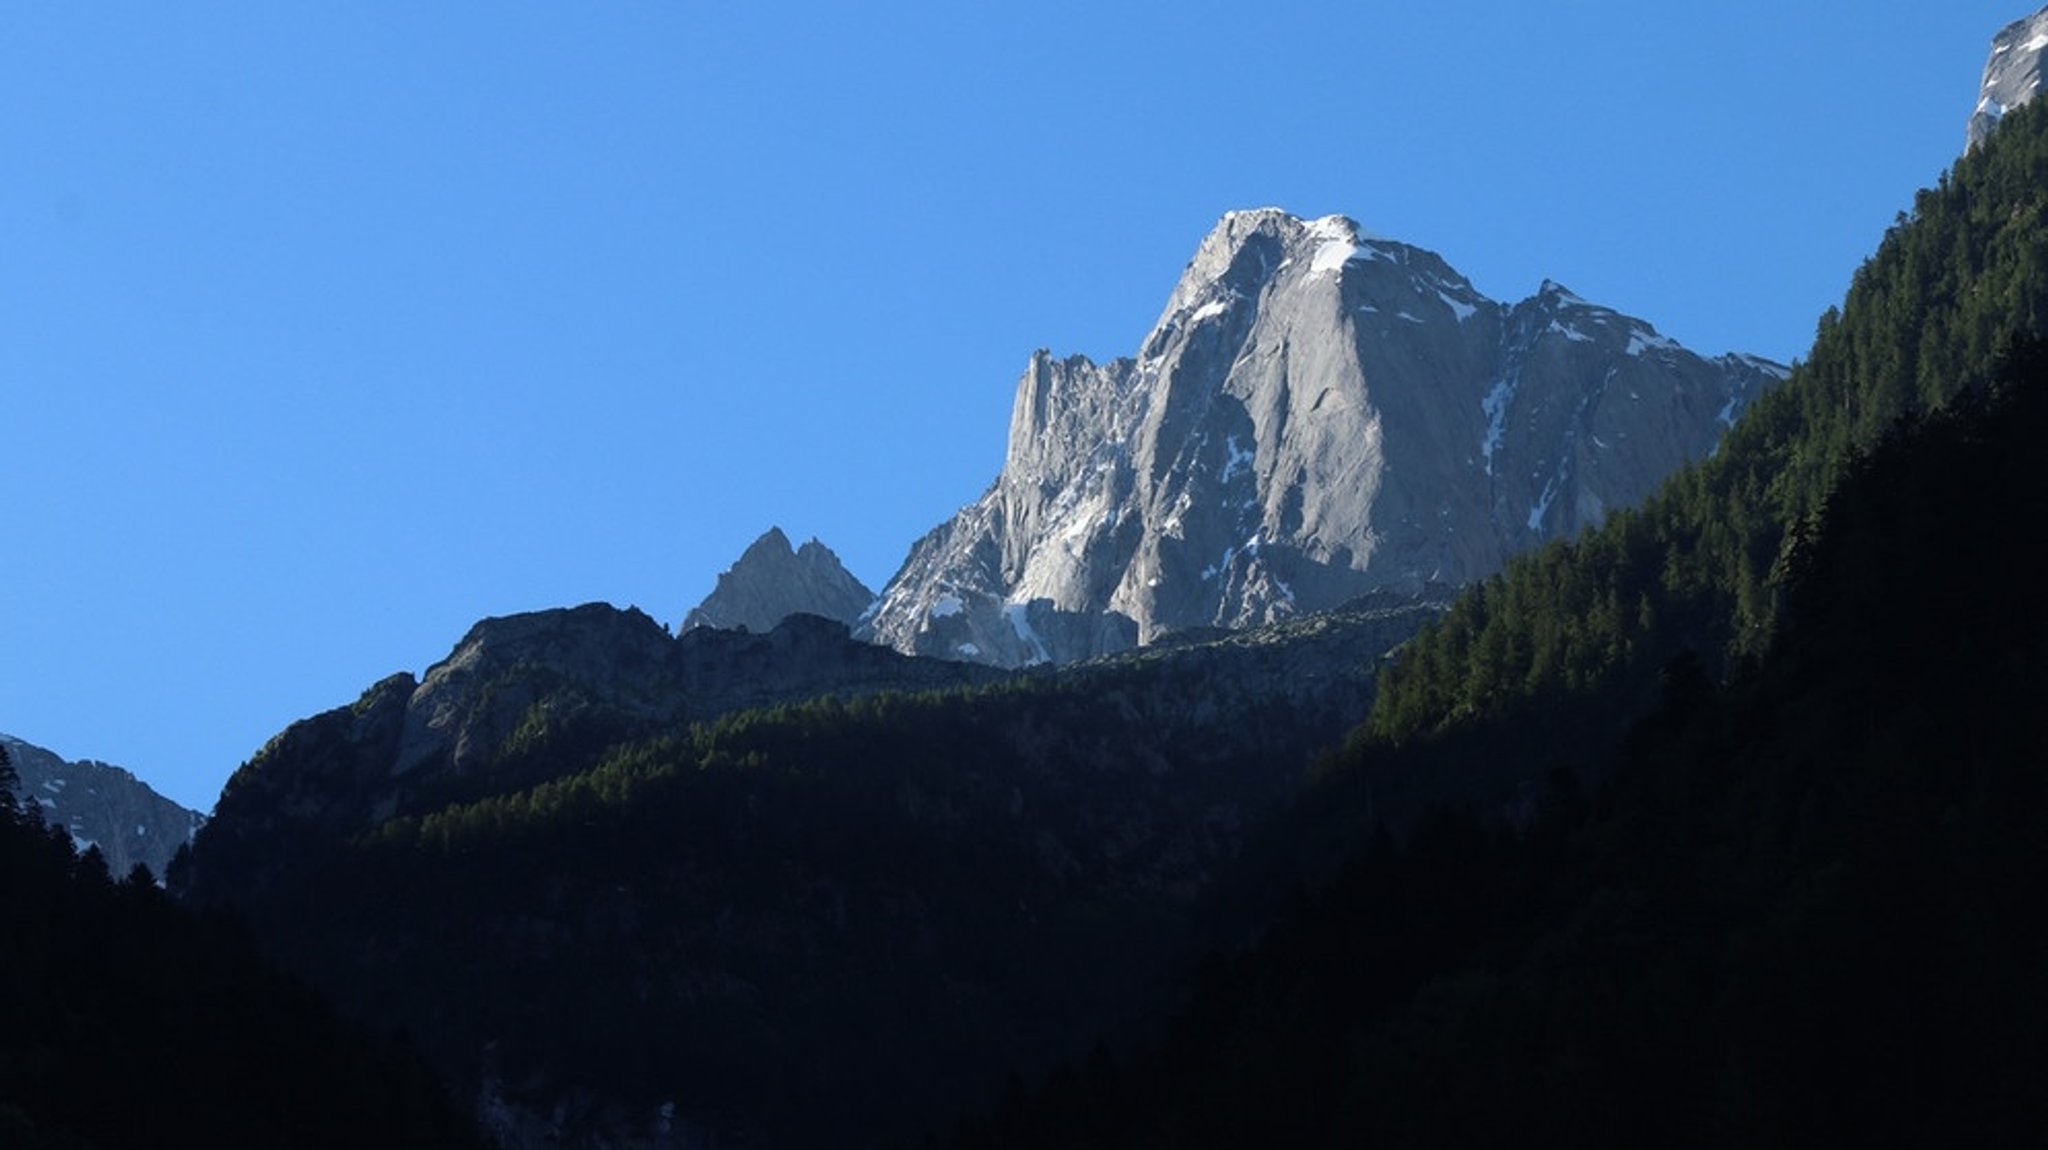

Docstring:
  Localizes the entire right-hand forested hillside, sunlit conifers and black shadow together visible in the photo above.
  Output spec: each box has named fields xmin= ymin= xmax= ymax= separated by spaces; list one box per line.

xmin=950 ymin=96 xmax=2048 ymax=1150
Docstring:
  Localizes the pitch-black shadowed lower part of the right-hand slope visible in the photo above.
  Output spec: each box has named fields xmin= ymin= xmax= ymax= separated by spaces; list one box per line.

xmin=937 ymin=342 xmax=2048 ymax=1150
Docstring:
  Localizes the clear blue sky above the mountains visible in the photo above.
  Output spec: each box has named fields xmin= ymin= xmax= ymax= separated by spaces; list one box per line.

xmin=0 ymin=0 xmax=2030 ymax=808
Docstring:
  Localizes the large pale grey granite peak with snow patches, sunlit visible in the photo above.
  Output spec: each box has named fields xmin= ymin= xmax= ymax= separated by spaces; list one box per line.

xmin=858 ymin=209 xmax=1786 ymax=665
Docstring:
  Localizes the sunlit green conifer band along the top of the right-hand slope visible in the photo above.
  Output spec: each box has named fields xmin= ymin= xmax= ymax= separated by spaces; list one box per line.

xmin=1370 ymin=98 xmax=2048 ymax=757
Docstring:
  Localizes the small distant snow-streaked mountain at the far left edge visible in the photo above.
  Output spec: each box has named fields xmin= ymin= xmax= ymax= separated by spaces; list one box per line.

xmin=0 ymin=735 xmax=207 ymax=878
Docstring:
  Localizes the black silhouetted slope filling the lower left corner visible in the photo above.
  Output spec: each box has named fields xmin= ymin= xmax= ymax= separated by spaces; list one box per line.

xmin=0 ymin=747 xmax=481 ymax=1150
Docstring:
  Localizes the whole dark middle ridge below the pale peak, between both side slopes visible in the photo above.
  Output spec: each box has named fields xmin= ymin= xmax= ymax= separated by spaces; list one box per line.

xmin=174 ymin=598 xmax=1436 ymax=1146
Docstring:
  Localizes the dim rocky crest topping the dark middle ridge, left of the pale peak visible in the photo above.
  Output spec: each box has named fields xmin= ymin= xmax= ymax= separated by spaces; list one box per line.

xmin=193 ymin=604 xmax=1001 ymax=886
